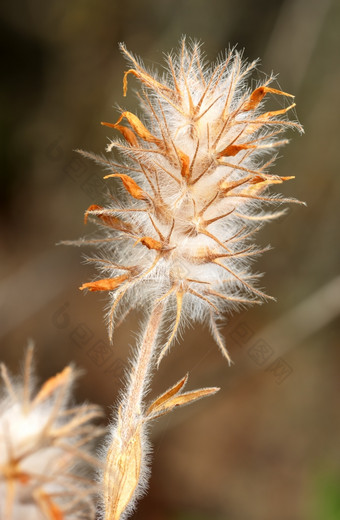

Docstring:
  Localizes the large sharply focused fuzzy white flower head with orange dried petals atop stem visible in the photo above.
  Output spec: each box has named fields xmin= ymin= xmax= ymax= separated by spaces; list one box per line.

xmin=81 ymin=40 xmax=301 ymax=366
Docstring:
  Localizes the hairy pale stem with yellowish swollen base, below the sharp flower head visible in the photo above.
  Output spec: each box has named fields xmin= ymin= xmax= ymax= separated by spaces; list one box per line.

xmin=103 ymin=303 xmax=164 ymax=520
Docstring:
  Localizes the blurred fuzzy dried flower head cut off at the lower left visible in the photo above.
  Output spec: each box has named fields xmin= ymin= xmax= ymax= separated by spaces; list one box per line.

xmin=0 ymin=346 xmax=103 ymax=520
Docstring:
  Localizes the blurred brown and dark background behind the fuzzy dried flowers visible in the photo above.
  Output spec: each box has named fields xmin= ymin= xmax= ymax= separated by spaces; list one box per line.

xmin=0 ymin=0 xmax=340 ymax=520
